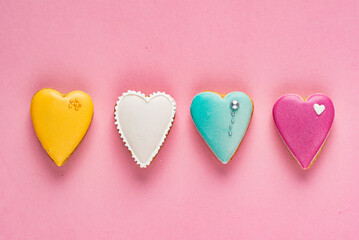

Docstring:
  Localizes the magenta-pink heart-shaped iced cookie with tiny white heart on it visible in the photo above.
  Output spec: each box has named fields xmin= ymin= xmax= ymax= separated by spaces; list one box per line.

xmin=273 ymin=94 xmax=334 ymax=169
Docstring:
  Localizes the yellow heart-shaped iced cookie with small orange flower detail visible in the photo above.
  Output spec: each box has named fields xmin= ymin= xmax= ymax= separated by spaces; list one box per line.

xmin=30 ymin=88 xmax=93 ymax=166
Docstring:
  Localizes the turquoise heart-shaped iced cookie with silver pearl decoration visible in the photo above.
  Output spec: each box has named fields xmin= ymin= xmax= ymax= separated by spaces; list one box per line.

xmin=191 ymin=92 xmax=253 ymax=164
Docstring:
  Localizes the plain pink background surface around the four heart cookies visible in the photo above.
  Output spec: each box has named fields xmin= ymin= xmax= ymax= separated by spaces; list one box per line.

xmin=0 ymin=0 xmax=359 ymax=240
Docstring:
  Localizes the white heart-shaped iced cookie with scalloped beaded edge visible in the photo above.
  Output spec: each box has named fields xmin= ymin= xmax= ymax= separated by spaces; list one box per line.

xmin=115 ymin=91 xmax=176 ymax=168
